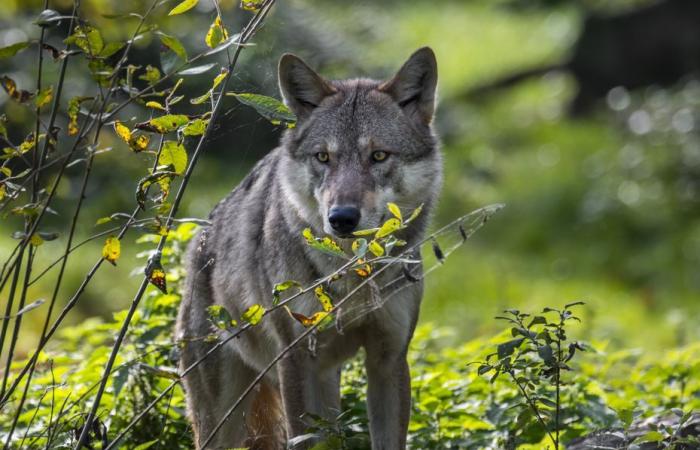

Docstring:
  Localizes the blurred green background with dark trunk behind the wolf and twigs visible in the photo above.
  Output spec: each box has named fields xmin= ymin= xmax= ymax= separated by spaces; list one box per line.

xmin=0 ymin=0 xmax=700 ymax=352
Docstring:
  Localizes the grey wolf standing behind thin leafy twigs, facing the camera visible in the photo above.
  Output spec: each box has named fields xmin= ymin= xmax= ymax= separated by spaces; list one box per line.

xmin=176 ymin=47 xmax=442 ymax=450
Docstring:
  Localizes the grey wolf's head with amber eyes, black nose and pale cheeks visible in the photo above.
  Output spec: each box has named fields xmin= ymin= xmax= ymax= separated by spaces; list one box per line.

xmin=279 ymin=47 xmax=442 ymax=237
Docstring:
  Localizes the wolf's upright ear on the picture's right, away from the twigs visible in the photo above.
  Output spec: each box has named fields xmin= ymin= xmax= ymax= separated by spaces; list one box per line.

xmin=379 ymin=47 xmax=437 ymax=125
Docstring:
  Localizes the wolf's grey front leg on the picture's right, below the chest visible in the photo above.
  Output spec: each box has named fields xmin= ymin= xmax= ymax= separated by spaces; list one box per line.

xmin=366 ymin=347 xmax=411 ymax=450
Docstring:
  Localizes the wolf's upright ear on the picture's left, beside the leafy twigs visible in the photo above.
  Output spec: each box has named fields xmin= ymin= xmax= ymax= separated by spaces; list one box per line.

xmin=278 ymin=53 xmax=336 ymax=120
